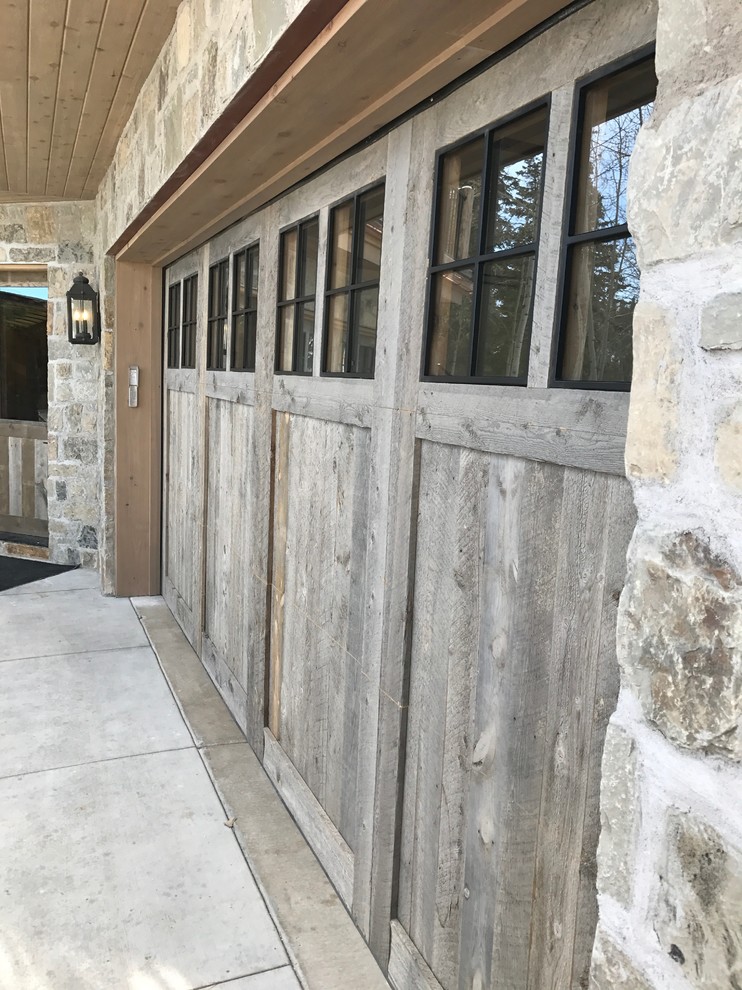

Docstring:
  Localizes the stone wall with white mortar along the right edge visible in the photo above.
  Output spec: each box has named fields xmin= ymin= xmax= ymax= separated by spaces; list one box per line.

xmin=592 ymin=0 xmax=742 ymax=990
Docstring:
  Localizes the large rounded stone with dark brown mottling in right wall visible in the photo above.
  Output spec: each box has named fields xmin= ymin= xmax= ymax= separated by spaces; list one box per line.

xmin=617 ymin=533 xmax=742 ymax=761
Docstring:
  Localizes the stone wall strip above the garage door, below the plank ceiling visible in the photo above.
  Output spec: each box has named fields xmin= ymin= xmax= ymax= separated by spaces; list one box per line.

xmin=98 ymin=0 xmax=307 ymax=249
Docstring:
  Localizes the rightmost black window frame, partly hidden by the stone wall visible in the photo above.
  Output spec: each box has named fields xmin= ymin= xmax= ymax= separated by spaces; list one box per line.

xmin=548 ymin=42 xmax=656 ymax=392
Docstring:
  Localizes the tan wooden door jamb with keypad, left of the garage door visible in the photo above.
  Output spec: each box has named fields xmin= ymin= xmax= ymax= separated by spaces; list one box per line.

xmin=114 ymin=262 xmax=162 ymax=596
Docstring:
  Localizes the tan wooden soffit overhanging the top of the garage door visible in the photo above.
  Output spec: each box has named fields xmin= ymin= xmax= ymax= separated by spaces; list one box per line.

xmin=117 ymin=0 xmax=570 ymax=264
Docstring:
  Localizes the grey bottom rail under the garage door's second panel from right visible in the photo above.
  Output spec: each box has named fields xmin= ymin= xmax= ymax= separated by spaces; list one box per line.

xmin=263 ymin=729 xmax=353 ymax=905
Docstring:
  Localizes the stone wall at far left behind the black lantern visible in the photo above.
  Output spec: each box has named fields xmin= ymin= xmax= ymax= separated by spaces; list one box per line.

xmin=0 ymin=203 xmax=101 ymax=567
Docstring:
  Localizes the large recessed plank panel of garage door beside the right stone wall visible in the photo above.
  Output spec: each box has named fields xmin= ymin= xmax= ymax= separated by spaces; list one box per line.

xmin=398 ymin=443 xmax=633 ymax=990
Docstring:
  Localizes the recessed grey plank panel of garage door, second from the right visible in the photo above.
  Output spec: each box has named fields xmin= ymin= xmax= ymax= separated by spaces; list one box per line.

xmin=272 ymin=416 xmax=369 ymax=848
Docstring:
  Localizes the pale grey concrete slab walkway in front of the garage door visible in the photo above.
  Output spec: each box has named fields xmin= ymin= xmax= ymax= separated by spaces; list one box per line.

xmin=0 ymin=571 xmax=300 ymax=990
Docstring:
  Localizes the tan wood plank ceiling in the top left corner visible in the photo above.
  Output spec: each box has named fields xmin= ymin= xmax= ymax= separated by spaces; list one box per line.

xmin=0 ymin=0 xmax=178 ymax=202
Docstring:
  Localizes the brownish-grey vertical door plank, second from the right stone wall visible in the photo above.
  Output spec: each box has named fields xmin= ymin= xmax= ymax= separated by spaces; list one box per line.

xmin=528 ymin=469 xmax=611 ymax=990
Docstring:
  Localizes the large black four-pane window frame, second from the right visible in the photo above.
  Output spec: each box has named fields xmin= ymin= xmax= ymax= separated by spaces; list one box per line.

xmin=420 ymin=93 xmax=552 ymax=388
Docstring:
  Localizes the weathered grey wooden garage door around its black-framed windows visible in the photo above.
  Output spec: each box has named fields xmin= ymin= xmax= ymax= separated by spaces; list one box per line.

xmin=163 ymin=0 xmax=653 ymax=990
